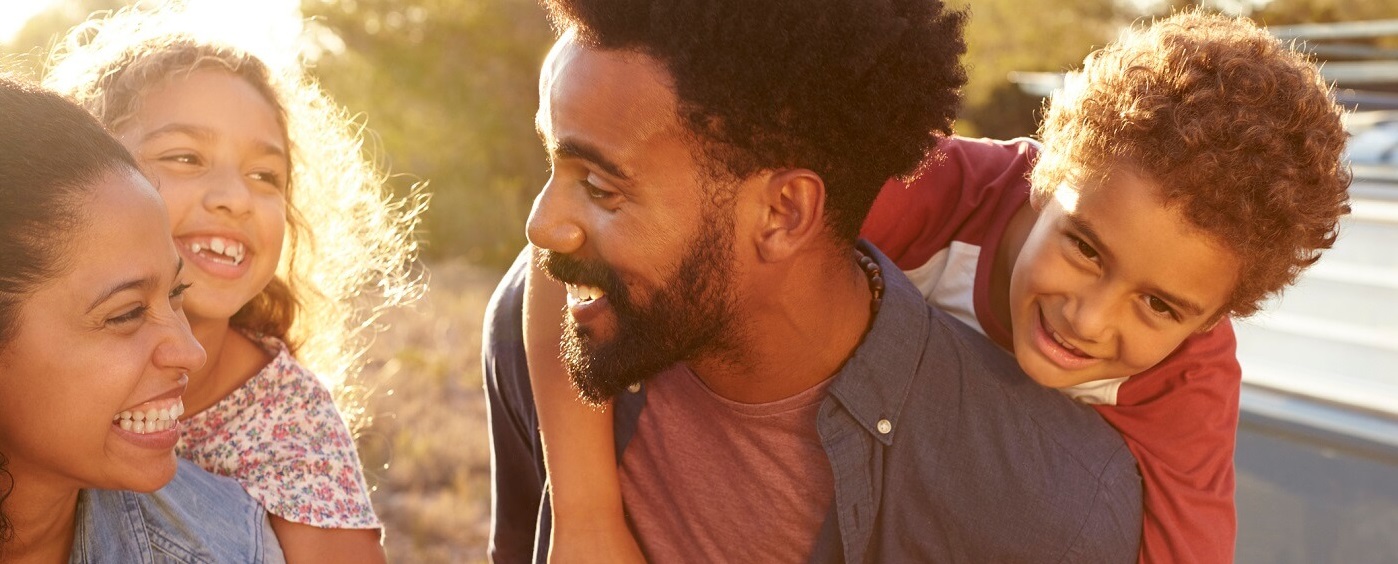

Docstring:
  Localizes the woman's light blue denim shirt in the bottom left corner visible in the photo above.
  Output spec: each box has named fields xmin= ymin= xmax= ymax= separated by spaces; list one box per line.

xmin=69 ymin=459 xmax=285 ymax=564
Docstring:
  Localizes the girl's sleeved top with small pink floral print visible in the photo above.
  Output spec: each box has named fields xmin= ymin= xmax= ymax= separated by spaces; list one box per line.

xmin=175 ymin=337 xmax=383 ymax=529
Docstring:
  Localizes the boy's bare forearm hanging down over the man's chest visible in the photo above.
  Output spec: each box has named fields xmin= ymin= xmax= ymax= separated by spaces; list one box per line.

xmin=524 ymin=257 xmax=644 ymax=563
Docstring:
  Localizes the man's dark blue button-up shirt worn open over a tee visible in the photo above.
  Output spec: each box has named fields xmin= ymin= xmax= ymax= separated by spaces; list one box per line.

xmin=482 ymin=242 xmax=1141 ymax=563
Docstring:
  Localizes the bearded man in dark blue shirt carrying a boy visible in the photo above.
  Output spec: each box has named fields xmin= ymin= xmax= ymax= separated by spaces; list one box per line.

xmin=484 ymin=0 xmax=1141 ymax=561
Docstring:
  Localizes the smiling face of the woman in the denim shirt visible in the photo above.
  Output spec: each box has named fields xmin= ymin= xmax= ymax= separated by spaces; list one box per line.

xmin=0 ymin=169 xmax=204 ymax=491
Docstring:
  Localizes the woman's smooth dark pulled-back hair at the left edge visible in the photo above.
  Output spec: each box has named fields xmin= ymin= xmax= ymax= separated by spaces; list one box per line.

xmin=0 ymin=77 xmax=137 ymax=551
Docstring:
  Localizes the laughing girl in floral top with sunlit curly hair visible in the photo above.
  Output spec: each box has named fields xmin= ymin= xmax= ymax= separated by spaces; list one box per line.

xmin=46 ymin=4 xmax=419 ymax=561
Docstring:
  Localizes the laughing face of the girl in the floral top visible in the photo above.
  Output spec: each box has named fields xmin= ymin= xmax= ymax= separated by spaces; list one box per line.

xmin=117 ymin=69 xmax=289 ymax=327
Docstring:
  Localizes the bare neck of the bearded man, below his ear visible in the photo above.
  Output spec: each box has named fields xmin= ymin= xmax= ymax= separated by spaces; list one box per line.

xmin=689 ymin=246 xmax=872 ymax=403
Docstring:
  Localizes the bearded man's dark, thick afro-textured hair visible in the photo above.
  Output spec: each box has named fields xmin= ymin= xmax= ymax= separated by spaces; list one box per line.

xmin=544 ymin=0 xmax=966 ymax=244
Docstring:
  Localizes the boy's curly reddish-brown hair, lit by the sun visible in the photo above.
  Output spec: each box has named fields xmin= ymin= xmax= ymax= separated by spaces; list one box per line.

xmin=1033 ymin=11 xmax=1350 ymax=316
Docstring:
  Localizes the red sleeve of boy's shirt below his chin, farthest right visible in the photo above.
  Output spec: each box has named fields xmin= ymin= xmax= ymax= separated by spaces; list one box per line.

xmin=1095 ymin=319 xmax=1243 ymax=564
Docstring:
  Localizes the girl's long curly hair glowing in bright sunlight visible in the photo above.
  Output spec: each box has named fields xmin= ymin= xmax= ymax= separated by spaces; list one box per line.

xmin=45 ymin=4 xmax=426 ymax=423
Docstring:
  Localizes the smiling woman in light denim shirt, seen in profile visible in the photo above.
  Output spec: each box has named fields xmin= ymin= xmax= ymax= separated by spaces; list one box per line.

xmin=0 ymin=80 xmax=280 ymax=563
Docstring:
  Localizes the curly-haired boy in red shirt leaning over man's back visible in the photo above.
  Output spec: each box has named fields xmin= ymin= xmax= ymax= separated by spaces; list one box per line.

xmin=524 ymin=13 xmax=1349 ymax=563
